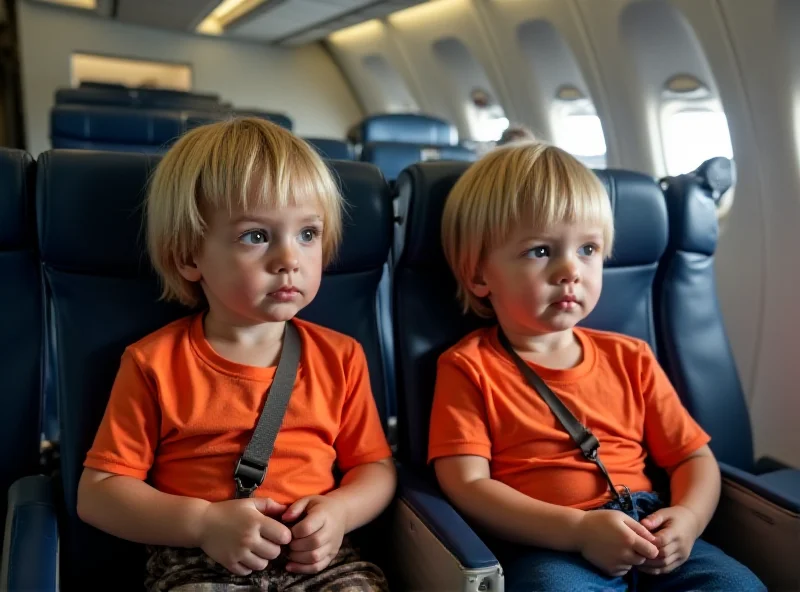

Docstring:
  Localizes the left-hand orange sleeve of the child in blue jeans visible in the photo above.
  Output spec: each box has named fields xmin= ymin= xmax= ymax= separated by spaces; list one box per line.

xmin=428 ymin=353 xmax=492 ymax=462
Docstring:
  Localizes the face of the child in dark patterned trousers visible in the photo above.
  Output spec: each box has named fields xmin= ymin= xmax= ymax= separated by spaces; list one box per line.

xmin=185 ymin=203 xmax=324 ymax=325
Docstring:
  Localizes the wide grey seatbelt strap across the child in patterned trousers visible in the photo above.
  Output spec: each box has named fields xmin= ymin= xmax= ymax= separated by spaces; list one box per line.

xmin=233 ymin=321 xmax=302 ymax=499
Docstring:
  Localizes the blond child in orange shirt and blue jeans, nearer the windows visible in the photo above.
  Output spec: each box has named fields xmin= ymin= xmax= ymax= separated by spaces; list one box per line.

xmin=429 ymin=141 xmax=764 ymax=591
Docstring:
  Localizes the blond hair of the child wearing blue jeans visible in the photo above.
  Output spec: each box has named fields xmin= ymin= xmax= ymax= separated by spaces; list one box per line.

xmin=442 ymin=141 xmax=614 ymax=318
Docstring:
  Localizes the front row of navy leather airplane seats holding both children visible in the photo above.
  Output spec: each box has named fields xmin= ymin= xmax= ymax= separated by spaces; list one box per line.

xmin=0 ymin=150 xmax=800 ymax=591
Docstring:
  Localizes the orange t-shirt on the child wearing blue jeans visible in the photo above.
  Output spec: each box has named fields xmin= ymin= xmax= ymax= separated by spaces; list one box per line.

xmin=428 ymin=327 xmax=710 ymax=509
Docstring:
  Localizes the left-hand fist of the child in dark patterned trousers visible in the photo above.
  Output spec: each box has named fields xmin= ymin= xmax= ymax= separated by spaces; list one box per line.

xmin=200 ymin=498 xmax=292 ymax=576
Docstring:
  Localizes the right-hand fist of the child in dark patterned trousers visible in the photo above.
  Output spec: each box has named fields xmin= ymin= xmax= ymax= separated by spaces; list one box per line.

xmin=283 ymin=495 xmax=345 ymax=574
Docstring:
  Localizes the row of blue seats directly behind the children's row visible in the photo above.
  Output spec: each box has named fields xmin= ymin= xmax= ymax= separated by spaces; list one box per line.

xmin=50 ymin=101 xmax=475 ymax=182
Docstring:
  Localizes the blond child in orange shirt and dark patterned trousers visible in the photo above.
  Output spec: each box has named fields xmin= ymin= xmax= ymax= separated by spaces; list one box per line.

xmin=78 ymin=119 xmax=396 ymax=591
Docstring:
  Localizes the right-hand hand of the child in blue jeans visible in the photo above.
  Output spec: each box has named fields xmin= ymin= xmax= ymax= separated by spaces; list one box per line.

xmin=641 ymin=506 xmax=700 ymax=575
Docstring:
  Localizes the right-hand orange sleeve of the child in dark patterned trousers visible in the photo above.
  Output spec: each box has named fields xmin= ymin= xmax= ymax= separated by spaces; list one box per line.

xmin=334 ymin=344 xmax=392 ymax=471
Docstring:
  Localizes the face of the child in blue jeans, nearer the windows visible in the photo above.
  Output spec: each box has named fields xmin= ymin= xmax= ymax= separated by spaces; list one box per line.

xmin=472 ymin=223 xmax=603 ymax=335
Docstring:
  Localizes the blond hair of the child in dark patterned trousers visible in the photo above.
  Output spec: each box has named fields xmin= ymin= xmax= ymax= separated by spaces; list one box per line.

xmin=146 ymin=118 xmax=343 ymax=306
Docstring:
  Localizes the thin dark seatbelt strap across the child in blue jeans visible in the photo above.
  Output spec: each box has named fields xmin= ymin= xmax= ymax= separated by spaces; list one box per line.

xmin=497 ymin=326 xmax=630 ymax=504
